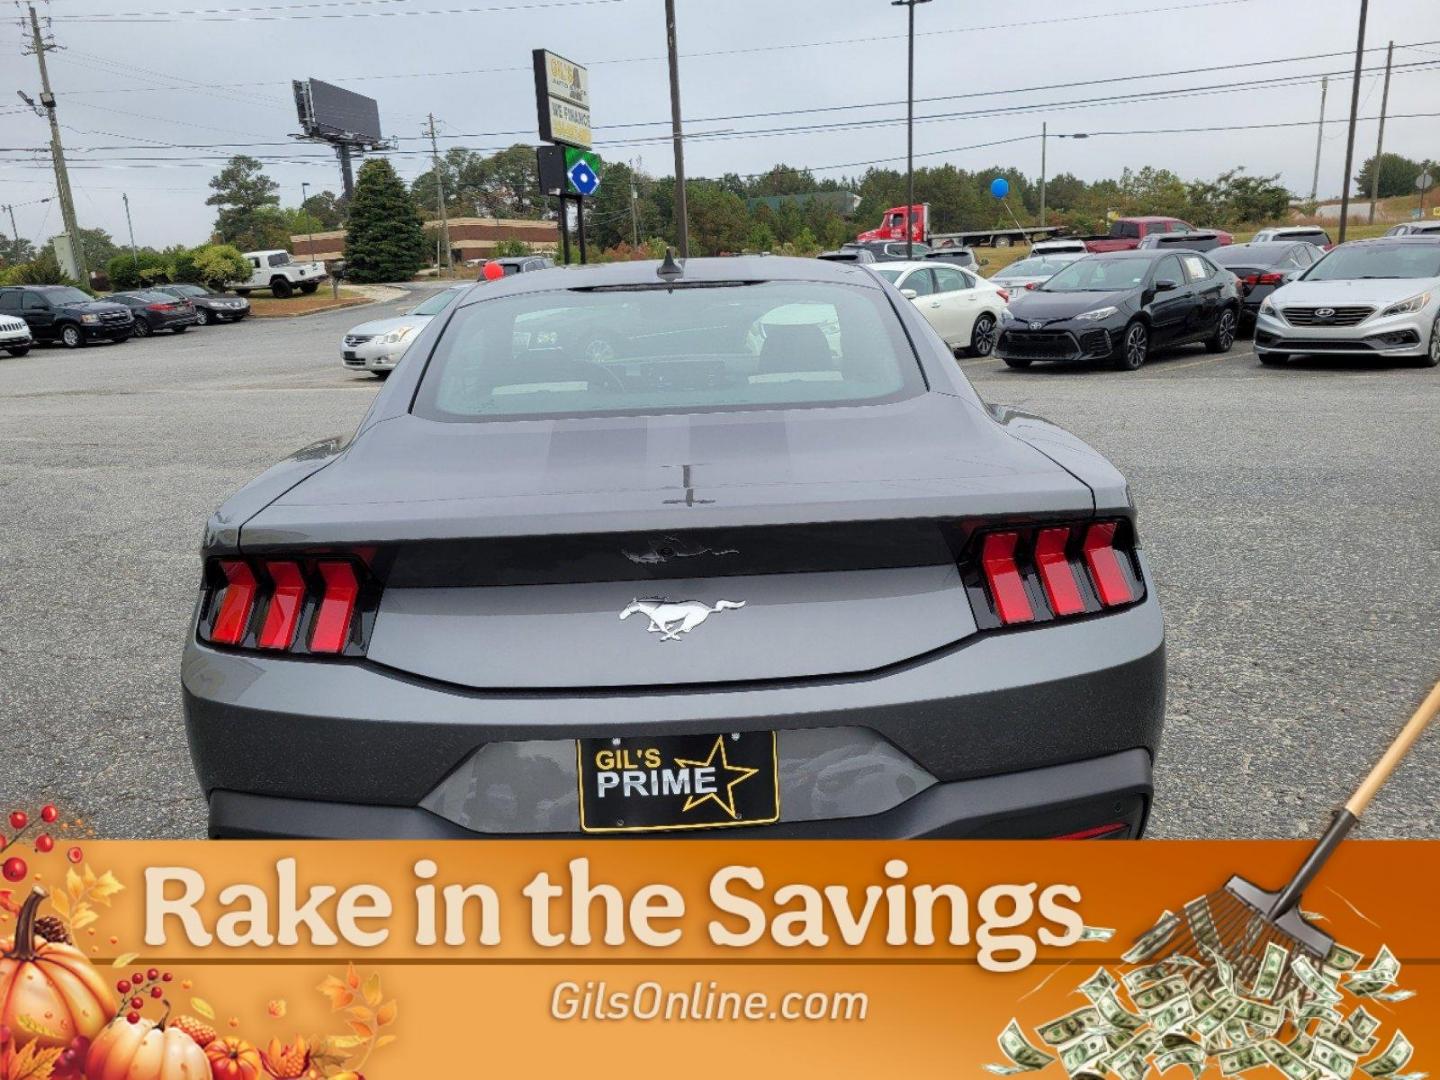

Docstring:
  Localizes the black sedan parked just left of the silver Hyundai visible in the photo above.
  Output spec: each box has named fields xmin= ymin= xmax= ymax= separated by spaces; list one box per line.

xmin=995 ymin=251 xmax=1240 ymax=372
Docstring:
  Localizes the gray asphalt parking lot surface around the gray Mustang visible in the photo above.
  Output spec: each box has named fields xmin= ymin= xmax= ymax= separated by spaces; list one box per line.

xmin=0 ymin=288 xmax=1440 ymax=838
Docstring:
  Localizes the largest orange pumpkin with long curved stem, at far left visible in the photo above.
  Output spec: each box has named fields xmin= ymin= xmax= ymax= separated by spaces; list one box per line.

xmin=0 ymin=888 xmax=115 ymax=1048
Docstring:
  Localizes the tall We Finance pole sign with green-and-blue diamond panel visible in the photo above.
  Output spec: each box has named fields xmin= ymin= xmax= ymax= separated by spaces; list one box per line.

xmin=531 ymin=49 xmax=600 ymax=262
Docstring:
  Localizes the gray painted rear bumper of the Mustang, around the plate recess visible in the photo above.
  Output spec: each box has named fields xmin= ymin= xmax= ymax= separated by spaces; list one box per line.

xmin=181 ymin=575 xmax=1165 ymax=835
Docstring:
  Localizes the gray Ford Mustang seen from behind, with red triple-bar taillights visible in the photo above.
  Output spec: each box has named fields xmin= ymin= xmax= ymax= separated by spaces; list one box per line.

xmin=183 ymin=258 xmax=1165 ymax=838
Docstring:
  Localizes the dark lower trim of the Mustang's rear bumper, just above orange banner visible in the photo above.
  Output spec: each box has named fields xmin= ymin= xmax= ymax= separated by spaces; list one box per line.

xmin=210 ymin=749 xmax=1153 ymax=840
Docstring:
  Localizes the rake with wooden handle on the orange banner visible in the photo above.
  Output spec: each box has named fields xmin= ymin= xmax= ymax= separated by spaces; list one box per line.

xmin=1130 ymin=683 xmax=1440 ymax=1001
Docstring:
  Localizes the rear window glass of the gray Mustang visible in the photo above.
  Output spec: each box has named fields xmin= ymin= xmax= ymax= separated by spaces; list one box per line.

xmin=413 ymin=281 xmax=924 ymax=420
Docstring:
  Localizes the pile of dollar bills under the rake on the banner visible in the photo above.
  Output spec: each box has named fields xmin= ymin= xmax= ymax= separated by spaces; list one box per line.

xmin=985 ymin=899 xmax=1427 ymax=1080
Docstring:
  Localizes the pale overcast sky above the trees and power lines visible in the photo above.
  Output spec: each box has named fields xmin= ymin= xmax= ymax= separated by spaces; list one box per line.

xmin=0 ymin=0 xmax=1440 ymax=246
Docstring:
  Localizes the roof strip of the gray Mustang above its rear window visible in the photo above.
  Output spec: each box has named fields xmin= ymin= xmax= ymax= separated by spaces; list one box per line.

xmin=452 ymin=255 xmax=875 ymax=302
